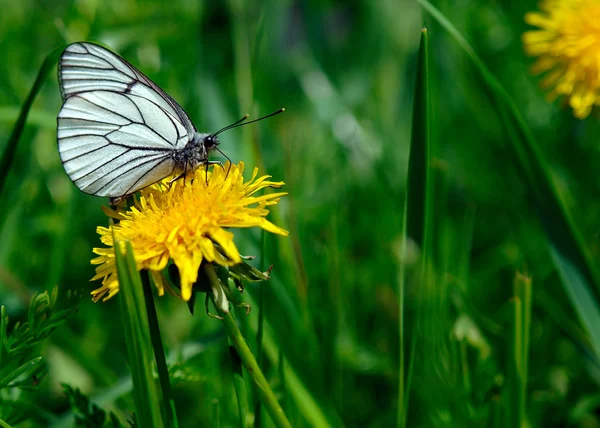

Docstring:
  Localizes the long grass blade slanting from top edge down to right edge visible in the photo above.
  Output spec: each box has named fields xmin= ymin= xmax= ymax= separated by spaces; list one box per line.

xmin=418 ymin=0 xmax=600 ymax=364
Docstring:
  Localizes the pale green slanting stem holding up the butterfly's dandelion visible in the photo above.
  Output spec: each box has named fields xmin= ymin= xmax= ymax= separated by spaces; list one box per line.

xmin=203 ymin=263 xmax=292 ymax=428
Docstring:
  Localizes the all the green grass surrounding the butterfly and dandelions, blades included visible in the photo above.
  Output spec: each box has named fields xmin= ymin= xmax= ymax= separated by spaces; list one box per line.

xmin=0 ymin=0 xmax=600 ymax=427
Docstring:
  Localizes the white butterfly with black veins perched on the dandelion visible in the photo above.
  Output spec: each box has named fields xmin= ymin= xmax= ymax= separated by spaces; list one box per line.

xmin=57 ymin=42 xmax=284 ymax=201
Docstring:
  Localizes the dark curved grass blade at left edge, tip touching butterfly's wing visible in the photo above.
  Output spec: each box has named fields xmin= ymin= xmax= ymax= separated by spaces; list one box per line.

xmin=0 ymin=46 xmax=65 ymax=195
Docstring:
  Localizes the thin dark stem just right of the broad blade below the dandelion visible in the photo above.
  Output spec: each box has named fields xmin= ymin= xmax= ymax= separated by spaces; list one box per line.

xmin=141 ymin=270 xmax=179 ymax=428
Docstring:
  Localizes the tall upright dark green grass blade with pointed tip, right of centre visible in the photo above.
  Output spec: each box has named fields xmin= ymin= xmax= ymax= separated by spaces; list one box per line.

xmin=397 ymin=29 xmax=433 ymax=427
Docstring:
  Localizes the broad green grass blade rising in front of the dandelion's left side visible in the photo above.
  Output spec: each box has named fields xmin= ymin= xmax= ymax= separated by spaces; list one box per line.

xmin=113 ymin=237 xmax=164 ymax=427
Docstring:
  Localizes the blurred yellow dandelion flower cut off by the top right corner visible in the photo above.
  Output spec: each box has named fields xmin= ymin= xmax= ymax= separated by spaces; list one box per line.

xmin=523 ymin=0 xmax=600 ymax=119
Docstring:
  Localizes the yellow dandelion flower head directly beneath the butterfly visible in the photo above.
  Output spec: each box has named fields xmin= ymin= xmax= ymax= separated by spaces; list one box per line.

xmin=92 ymin=162 xmax=288 ymax=301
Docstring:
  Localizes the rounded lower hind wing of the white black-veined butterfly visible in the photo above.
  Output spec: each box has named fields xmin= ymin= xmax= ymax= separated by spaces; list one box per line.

xmin=58 ymin=91 xmax=185 ymax=197
